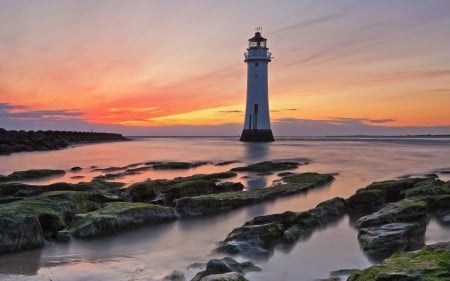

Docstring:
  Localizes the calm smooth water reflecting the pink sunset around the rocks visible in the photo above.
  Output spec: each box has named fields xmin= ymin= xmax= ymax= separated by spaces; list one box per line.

xmin=0 ymin=138 xmax=450 ymax=281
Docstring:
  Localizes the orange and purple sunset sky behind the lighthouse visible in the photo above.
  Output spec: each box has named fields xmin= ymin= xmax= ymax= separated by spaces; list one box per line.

xmin=0 ymin=0 xmax=450 ymax=136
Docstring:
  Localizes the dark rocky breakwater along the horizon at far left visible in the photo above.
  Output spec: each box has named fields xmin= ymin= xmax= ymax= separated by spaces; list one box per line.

xmin=0 ymin=128 xmax=129 ymax=155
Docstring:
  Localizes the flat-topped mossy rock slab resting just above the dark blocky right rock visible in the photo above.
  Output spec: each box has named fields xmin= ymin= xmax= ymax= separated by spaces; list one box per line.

xmin=356 ymin=199 xmax=428 ymax=228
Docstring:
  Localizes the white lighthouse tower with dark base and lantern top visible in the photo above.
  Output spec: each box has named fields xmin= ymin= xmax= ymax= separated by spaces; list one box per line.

xmin=240 ymin=28 xmax=274 ymax=142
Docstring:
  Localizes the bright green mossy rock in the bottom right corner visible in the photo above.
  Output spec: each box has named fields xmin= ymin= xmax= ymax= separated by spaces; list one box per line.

xmin=348 ymin=242 xmax=450 ymax=281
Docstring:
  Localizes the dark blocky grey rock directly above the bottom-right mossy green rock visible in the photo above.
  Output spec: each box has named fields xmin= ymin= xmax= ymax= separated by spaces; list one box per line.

xmin=358 ymin=222 xmax=425 ymax=261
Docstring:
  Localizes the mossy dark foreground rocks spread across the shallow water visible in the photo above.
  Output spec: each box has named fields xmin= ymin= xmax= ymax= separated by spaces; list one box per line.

xmin=0 ymin=161 xmax=450 ymax=281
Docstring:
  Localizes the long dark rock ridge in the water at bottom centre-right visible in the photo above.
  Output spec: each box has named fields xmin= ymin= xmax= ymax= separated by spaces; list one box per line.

xmin=218 ymin=198 xmax=345 ymax=256
